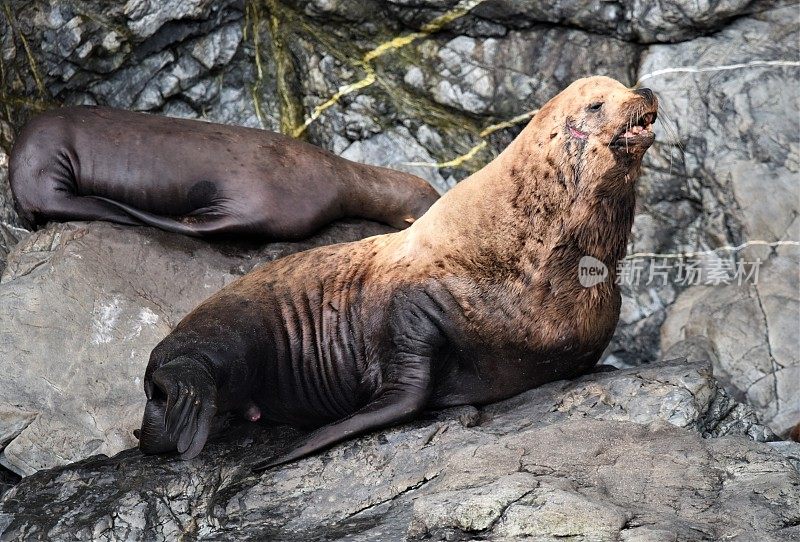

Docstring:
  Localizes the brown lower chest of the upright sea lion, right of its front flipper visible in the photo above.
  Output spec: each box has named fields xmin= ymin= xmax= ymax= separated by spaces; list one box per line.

xmin=428 ymin=278 xmax=619 ymax=405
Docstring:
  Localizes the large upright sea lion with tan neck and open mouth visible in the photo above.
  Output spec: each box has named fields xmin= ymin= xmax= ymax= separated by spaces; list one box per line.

xmin=140 ymin=77 xmax=657 ymax=468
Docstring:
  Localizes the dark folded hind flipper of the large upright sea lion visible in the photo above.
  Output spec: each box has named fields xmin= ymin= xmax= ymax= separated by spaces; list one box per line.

xmin=139 ymin=357 xmax=217 ymax=459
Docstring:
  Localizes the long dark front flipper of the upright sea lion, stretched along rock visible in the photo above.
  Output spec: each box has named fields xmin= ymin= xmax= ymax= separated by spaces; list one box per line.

xmin=253 ymin=368 xmax=431 ymax=472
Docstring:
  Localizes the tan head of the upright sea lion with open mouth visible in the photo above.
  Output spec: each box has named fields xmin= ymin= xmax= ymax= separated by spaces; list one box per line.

xmin=537 ymin=76 xmax=658 ymax=187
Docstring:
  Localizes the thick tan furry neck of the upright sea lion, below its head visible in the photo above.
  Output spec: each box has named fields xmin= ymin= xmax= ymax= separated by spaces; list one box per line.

xmin=406 ymin=112 xmax=641 ymax=285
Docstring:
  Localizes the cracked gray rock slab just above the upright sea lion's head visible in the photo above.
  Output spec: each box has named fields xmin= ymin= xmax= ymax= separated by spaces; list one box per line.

xmin=400 ymin=28 xmax=639 ymax=119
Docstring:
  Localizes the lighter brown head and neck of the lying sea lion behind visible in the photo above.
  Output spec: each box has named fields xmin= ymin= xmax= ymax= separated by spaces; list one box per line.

xmin=343 ymin=164 xmax=439 ymax=229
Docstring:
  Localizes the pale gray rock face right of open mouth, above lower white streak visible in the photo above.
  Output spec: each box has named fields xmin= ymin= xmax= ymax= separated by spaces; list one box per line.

xmin=639 ymin=7 xmax=800 ymax=255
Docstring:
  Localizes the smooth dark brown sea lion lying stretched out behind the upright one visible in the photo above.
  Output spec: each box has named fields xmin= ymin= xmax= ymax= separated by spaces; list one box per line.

xmin=9 ymin=107 xmax=439 ymax=239
